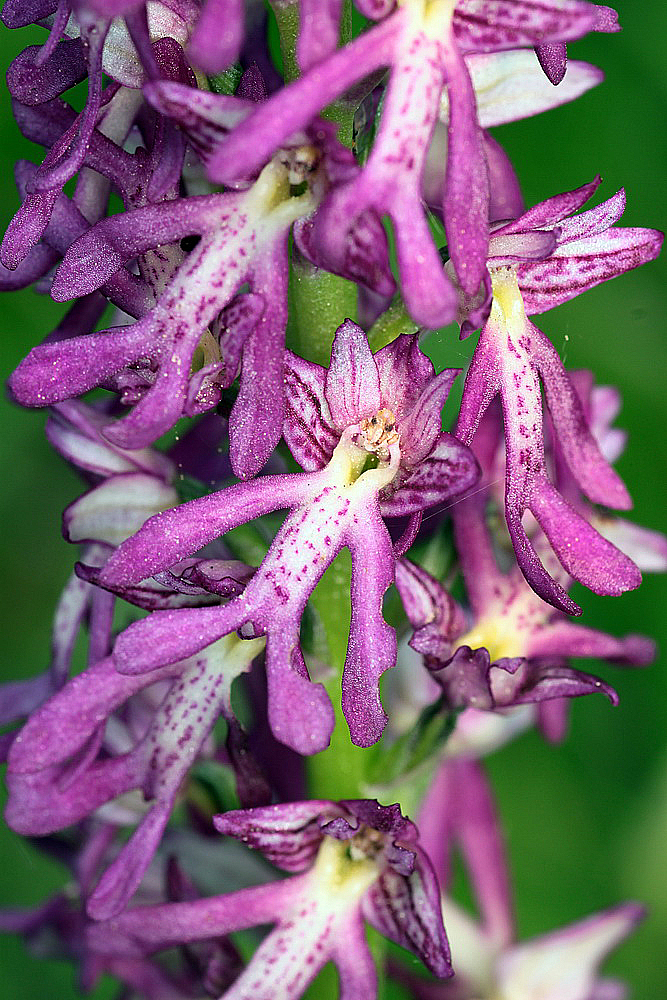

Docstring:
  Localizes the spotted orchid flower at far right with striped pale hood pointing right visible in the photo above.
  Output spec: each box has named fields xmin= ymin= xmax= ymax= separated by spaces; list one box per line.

xmin=457 ymin=180 xmax=663 ymax=614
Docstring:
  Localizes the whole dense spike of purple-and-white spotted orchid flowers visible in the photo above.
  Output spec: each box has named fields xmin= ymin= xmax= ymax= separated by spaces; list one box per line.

xmin=0 ymin=0 xmax=667 ymax=1000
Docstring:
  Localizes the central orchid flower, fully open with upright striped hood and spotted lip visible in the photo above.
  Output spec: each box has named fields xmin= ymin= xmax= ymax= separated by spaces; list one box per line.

xmin=94 ymin=320 xmax=477 ymax=753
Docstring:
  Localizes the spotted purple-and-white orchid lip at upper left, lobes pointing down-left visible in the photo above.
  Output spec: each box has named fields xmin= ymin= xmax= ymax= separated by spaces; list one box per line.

xmin=5 ymin=157 xmax=313 ymax=475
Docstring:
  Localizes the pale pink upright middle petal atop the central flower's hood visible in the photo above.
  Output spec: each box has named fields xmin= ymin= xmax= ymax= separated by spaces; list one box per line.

xmin=324 ymin=320 xmax=380 ymax=428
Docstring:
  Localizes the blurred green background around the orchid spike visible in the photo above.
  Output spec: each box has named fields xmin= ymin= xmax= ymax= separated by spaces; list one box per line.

xmin=0 ymin=2 xmax=667 ymax=1000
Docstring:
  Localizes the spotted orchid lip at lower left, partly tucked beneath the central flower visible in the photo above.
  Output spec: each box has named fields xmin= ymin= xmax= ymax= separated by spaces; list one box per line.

xmin=6 ymin=616 xmax=264 ymax=919
